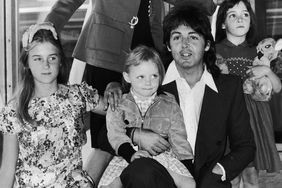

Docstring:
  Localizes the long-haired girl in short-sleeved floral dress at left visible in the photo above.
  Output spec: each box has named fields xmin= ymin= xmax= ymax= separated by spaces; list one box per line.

xmin=0 ymin=29 xmax=105 ymax=188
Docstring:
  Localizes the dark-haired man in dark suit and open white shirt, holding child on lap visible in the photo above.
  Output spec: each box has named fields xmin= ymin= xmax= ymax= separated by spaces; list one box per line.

xmin=121 ymin=5 xmax=255 ymax=188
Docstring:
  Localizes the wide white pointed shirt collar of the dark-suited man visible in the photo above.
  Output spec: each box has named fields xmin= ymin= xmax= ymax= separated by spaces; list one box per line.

xmin=163 ymin=61 xmax=218 ymax=93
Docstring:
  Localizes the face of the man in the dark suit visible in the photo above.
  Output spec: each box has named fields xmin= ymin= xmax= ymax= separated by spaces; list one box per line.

xmin=168 ymin=25 xmax=209 ymax=70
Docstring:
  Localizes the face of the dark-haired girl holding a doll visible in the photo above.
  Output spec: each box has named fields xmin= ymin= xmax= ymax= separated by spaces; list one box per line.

xmin=222 ymin=1 xmax=251 ymax=41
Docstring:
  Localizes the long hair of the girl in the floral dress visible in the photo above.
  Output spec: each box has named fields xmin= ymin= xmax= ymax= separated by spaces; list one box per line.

xmin=15 ymin=29 xmax=68 ymax=125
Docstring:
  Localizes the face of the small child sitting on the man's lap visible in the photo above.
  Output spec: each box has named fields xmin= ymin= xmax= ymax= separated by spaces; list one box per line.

xmin=123 ymin=60 xmax=160 ymax=98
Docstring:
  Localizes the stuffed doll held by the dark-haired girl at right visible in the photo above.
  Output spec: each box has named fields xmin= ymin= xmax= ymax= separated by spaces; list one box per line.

xmin=243 ymin=38 xmax=282 ymax=101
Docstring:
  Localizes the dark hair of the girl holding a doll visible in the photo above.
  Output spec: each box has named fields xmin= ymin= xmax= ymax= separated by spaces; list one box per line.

xmin=215 ymin=0 xmax=257 ymax=46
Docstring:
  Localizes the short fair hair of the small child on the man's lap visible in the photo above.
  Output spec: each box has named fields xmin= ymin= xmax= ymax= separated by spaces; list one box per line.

xmin=122 ymin=45 xmax=165 ymax=93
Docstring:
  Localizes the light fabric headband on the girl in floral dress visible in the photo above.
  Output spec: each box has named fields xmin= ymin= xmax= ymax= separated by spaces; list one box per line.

xmin=22 ymin=22 xmax=58 ymax=48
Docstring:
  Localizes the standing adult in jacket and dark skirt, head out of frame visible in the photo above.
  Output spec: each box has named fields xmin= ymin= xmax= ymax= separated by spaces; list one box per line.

xmin=23 ymin=0 xmax=215 ymax=185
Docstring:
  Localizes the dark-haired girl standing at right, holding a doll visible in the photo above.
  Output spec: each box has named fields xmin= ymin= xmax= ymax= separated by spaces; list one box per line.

xmin=216 ymin=0 xmax=281 ymax=187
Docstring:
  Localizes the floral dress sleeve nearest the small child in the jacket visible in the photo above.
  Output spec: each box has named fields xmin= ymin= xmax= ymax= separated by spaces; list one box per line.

xmin=78 ymin=82 xmax=100 ymax=111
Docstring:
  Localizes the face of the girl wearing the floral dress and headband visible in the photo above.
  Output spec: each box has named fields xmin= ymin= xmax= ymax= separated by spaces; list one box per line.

xmin=28 ymin=42 xmax=60 ymax=85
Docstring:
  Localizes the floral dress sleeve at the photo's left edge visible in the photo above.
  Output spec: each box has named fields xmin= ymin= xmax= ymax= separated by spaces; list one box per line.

xmin=0 ymin=106 xmax=21 ymax=134
